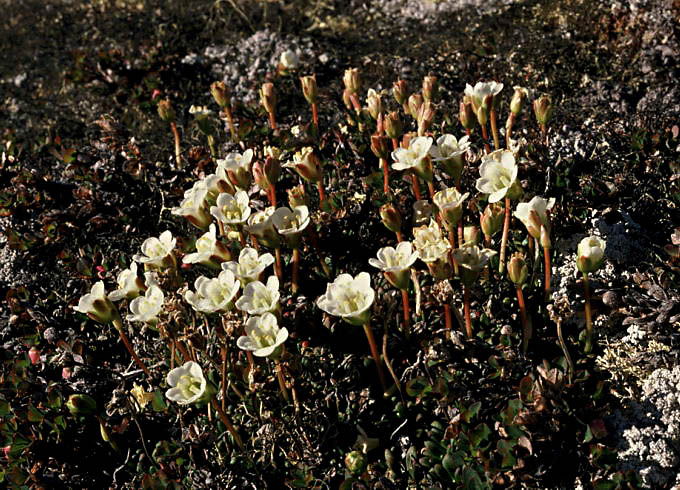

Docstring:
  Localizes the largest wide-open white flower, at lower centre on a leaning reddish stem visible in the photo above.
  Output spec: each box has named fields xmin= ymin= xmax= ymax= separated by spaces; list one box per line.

xmin=316 ymin=272 xmax=375 ymax=325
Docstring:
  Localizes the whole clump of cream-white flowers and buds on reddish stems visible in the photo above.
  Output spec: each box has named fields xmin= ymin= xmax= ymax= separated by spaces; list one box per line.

xmin=70 ymin=53 xmax=605 ymax=478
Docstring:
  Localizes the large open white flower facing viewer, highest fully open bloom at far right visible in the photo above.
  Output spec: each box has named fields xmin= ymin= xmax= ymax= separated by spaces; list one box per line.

xmin=476 ymin=150 xmax=521 ymax=203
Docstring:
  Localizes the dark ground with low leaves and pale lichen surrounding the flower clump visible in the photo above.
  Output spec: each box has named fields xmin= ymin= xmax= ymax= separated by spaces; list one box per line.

xmin=0 ymin=0 xmax=680 ymax=488
